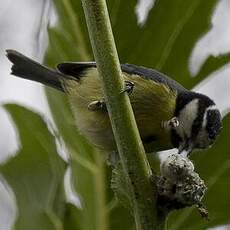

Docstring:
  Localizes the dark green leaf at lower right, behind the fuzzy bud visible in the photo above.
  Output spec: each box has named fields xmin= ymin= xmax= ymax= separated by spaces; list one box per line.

xmin=169 ymin=115 xmax=230 ymax=230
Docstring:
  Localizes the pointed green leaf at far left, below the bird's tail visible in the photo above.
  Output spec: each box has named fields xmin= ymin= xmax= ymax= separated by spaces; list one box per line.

xmin=0 ymin=104 xmax=65 ymax=230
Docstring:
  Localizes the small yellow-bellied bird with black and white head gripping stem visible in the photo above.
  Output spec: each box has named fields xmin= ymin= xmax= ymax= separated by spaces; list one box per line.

xmin=6 ymin=50 xmax=221 ymax=154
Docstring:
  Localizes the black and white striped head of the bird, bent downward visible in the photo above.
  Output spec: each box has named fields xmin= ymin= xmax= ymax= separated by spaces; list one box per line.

xmin=172 ymin=91 xmax=222 ymax=153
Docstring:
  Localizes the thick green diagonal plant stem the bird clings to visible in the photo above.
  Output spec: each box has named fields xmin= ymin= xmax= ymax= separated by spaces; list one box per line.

xmin=82 ymin=0 xmax=162 ymax=230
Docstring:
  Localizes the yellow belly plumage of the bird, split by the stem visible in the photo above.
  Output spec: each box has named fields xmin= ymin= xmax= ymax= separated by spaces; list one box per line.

xmin=65 ymin=68 xmax=176 ymax=152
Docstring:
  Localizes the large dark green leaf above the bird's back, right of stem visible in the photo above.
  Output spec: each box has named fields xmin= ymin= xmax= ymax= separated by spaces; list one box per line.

xmin=109 ymin=0 xmax=218 ymax=88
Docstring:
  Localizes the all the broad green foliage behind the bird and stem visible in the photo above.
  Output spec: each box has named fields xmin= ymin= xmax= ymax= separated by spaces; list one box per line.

xmin=0 ymin=0 xmax=230 ymax=230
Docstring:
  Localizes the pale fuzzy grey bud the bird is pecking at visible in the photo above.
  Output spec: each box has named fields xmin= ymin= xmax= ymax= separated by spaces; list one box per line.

xmin=157 ymin=154 xmax=206 ymax=210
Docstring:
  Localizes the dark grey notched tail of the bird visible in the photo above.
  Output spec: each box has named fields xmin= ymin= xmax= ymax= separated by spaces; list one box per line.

xmin=6 ymin=50 xmax=70 ymax=91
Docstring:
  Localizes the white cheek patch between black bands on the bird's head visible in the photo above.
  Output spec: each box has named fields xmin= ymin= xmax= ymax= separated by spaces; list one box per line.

xmin=177 ymin=99 xmax=199 ymax=138
